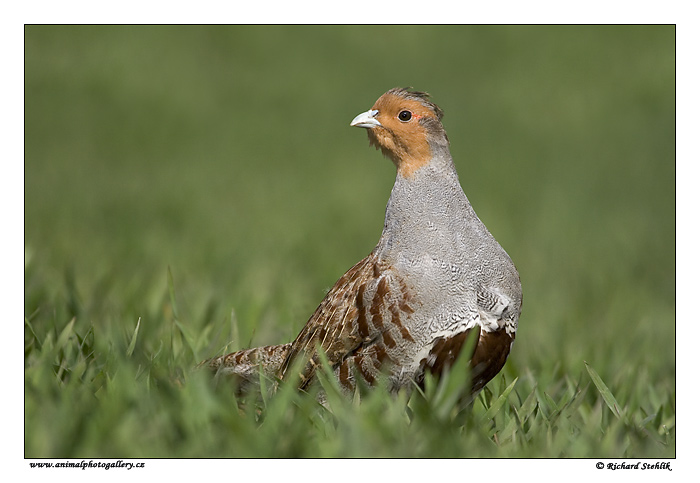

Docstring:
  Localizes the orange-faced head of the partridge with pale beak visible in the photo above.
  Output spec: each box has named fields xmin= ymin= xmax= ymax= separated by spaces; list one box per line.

xmin=350 ymin=87 xmax=448 ymax=178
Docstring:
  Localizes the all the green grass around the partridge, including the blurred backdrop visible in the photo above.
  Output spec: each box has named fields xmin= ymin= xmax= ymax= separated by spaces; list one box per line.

xmin=24 ymin=26 xmax=676 ymax=458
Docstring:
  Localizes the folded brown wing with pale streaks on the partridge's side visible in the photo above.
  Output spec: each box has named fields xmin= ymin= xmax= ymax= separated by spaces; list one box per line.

xmin=280 ymin=253 xmax=413 ymax=388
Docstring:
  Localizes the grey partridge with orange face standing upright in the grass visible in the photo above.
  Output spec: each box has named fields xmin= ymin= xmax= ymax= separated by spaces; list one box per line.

xmin=201 ymin=87 xmax=522 ymax=397
